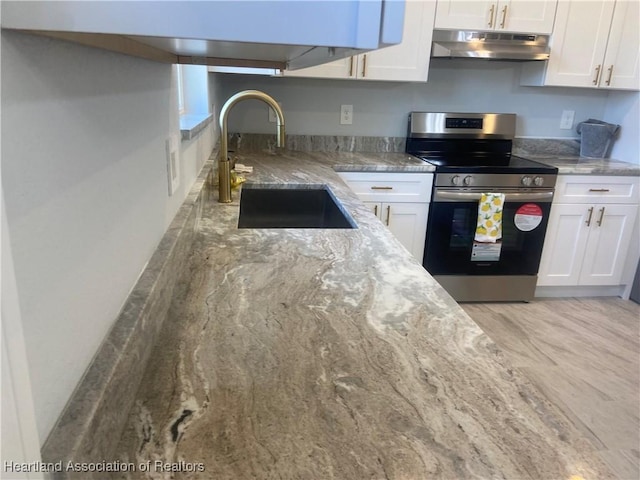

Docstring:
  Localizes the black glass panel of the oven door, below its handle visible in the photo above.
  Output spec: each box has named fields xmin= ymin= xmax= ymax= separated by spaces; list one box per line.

xmin=424 ymin=202 xmax=551 ymax=275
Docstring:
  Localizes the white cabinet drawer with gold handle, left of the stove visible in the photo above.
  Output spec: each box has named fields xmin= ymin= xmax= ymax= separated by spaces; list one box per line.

xmin=339 ymin=172 xmax=433 ymax=203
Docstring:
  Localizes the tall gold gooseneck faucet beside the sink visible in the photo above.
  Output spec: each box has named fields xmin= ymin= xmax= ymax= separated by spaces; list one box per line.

xmin=218 ymin=90 xmax=285 ymax=203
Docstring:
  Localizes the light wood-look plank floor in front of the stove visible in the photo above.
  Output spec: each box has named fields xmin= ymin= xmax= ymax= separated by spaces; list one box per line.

xmin=461 ymin=298 xmax=640 ymax=480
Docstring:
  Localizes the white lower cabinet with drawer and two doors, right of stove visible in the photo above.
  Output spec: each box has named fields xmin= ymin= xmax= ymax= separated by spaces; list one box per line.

xmin=538 ymin=176 xmax=640 ymax=286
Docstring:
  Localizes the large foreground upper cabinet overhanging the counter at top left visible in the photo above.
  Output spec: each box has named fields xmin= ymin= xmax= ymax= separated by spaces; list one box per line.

xmin=0 ymin=0 xmax=404 ymax=69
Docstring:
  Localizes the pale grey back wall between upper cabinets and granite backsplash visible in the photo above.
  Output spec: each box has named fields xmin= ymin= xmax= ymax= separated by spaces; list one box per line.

xmin=216 ymin=59 xmax=638 ymax=162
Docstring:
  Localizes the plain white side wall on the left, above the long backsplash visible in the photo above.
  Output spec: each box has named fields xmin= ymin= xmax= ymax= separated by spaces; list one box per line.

xmin=1 ymin=31 xmax=213 ymax=442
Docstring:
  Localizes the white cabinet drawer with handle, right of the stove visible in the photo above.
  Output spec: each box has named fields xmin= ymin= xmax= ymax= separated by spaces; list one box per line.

xmin=554 ymin=175 xmax=640 ymax=203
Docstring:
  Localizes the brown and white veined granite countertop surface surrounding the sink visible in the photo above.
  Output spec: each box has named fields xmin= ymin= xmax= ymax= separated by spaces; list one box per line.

xmin=114 ymin=152 xmax=611 ymax=480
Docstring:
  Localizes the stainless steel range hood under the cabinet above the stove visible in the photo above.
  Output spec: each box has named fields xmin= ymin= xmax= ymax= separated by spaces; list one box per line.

xmin=431 ymin=30 xmax=549 ymax=61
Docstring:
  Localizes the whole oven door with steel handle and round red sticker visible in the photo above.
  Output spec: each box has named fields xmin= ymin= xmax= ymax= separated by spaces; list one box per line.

xmin=423 ymin=188 xmax=553 ymax=275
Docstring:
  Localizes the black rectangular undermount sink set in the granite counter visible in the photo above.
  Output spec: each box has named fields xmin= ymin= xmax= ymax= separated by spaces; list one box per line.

xmin=238 ymin=184 xmax=357 ymax=228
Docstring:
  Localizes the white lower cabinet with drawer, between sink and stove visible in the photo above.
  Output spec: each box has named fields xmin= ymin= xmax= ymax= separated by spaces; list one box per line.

xmin=338 ymin=172 xmax=433 ymax=263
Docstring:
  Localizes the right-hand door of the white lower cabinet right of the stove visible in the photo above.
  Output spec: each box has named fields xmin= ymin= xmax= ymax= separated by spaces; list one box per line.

xmin=580 ymin=204 xmax=638 ymax=285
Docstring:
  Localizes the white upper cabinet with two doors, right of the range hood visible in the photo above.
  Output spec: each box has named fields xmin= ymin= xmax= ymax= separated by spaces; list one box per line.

xmin=523 ymin=0 xmax=640 ymax=90
